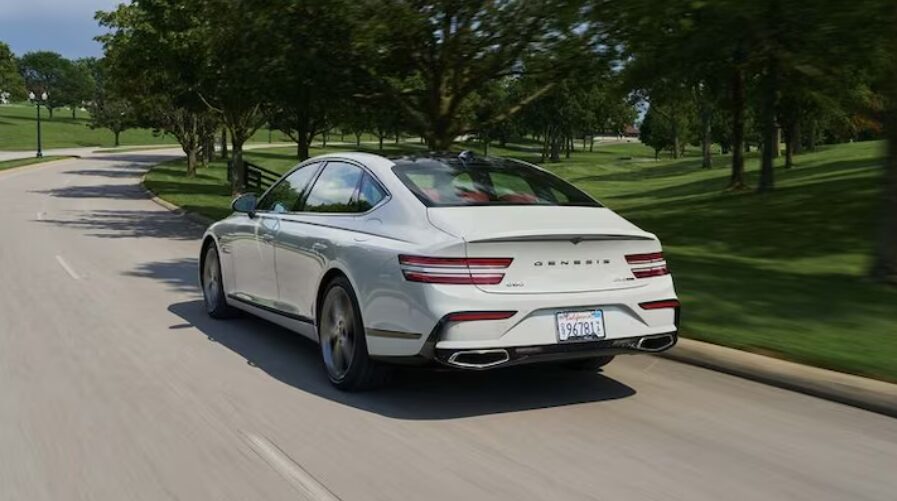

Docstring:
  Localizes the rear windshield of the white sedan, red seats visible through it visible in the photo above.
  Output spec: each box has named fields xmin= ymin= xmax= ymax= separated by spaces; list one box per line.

xmin=393 ymin=158 xmax=601 ymax=207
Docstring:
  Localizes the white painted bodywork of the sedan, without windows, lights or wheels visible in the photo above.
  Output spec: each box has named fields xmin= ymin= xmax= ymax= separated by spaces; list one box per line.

xmin=207 ymin=153 xmax=678 ymax=368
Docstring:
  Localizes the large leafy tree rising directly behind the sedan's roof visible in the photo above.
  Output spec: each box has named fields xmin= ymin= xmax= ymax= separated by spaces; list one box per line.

xmin=356 ymin=0 xmax=598 ymax=150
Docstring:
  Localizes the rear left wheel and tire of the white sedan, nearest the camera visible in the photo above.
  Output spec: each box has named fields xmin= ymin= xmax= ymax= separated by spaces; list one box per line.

xmin=316 ymin=276 xmax=389 ymax=391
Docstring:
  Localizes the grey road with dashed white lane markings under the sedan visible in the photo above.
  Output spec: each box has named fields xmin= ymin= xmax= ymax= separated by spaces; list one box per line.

xmin=0 ymin=152 xmax=897 ymax=501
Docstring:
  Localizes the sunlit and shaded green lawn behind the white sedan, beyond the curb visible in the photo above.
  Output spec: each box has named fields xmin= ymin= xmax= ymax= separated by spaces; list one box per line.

xmin=147 ymin=137 xmax=897 ymax=382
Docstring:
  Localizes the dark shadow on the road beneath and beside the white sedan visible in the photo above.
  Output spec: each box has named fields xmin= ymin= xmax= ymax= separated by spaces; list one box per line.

xmin=168 ymin=300 xmax=636 ymax=420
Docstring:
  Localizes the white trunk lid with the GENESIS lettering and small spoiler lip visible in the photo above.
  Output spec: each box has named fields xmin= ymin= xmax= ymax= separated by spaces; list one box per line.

xmin=428 ymin=206 xmax=660 ymax=294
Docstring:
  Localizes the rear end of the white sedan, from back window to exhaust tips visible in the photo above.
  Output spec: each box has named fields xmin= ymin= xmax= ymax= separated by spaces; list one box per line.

xmin=394 ymin=156 xmax=679 ymax=369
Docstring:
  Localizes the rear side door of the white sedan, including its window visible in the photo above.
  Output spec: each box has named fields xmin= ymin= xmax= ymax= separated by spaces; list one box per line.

xmin=277 ymin=161 xmax=385 ymax=319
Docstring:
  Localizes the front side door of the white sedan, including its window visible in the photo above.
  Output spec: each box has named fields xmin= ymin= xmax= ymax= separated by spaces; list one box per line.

xmin=231 ymin=163 xmax=321 ymax=308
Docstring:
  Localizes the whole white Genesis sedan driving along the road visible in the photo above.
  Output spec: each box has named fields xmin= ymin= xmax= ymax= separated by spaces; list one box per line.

xmin=199 ymin=152 xmax=679 ymax=390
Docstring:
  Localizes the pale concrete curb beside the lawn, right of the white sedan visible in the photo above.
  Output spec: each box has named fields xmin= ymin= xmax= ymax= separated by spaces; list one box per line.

xmin=657 ymin=338 xmax=897 ymax=417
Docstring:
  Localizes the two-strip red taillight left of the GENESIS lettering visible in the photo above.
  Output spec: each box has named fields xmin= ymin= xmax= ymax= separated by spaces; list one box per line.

xmin=399 ymin=255 xmax=514 ymax=285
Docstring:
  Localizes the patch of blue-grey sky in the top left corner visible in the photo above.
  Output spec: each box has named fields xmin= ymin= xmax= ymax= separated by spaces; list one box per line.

xmin=0 ymin=0 xmax=124 ymax=59
